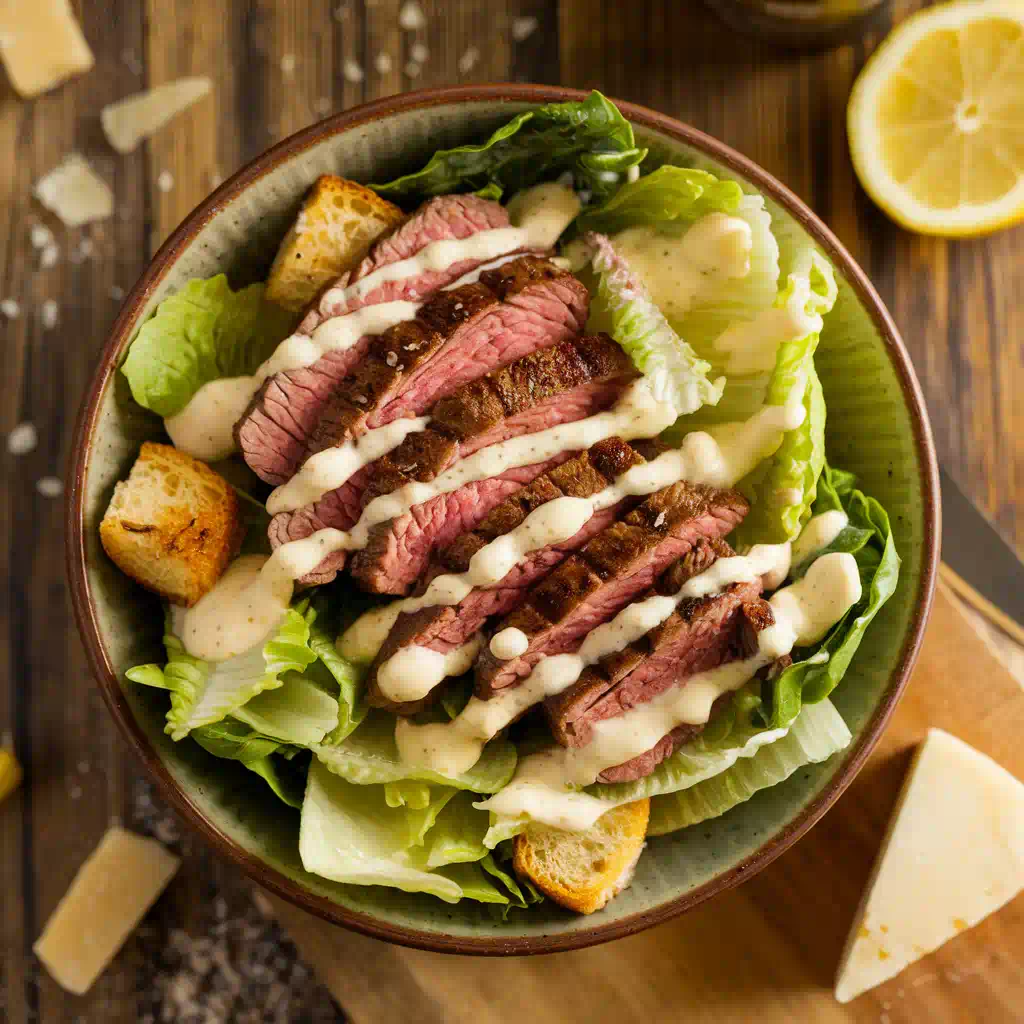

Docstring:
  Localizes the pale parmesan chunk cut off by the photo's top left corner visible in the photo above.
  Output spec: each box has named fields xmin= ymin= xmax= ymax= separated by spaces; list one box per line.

xmin=0 ymin=0 xmax=93 ymax=99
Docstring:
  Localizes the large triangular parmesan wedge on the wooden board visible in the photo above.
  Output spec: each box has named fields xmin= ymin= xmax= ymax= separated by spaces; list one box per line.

xmin=836 ymin=729 xmax=1024 ymax=1002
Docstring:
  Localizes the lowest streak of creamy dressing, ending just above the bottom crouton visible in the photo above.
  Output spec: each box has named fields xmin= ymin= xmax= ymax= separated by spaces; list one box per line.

xmin=473 ymin=552 xmax=861 ymax=830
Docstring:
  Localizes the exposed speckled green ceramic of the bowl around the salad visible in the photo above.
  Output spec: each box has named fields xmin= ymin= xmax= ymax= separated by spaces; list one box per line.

xmin=79 ymin=90 xmax=934 ymax=951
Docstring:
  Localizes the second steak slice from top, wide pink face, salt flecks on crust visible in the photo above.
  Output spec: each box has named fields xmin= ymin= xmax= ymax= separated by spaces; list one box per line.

xmin=307 ymin=256 xmax=590 ymax=455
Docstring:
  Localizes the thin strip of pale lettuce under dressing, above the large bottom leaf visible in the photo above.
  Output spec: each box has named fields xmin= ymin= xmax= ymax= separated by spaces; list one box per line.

xmin=312 ymin=712 xmax=516 ymax=793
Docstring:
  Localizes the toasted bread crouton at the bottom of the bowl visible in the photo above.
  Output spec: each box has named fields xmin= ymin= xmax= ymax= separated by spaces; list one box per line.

xmin=512 ymin=799 xmax=650 ymax=913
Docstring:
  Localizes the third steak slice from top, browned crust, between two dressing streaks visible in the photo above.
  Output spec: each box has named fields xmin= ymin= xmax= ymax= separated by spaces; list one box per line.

xmin=269 ymin=336 xmax=636 ymax=593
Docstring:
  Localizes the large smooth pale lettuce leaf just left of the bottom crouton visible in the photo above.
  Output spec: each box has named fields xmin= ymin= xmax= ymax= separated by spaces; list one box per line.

xmin=299 ymin=760 xmax=520 ymax=905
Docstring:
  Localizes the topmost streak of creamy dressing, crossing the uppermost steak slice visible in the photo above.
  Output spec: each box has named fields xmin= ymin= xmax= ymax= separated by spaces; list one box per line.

xmin=159 ymin=184 xmax=580 ymax=464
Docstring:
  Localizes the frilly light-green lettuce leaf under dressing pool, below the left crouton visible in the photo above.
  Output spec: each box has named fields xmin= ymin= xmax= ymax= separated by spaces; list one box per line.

xmin=126 ymin=608 xmax=316 ymax=740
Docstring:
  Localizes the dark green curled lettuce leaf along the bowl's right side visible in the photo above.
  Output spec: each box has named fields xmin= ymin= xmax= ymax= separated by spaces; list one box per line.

xmin=761 ymin=464 xmax=900 ymax=728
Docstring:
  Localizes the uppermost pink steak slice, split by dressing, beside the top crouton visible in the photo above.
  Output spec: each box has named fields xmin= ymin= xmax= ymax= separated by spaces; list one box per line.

xmin=236 ymin=196 xmax=509 ymax=483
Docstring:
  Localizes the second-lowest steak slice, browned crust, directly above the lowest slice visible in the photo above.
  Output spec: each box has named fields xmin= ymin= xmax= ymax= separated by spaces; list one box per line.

xmin=476 ymin=482 xmax=749 ymax=698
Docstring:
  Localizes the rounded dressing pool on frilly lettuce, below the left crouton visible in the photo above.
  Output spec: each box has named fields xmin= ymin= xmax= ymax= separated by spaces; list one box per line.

xmin=177 ymin=555 xmax=293 ymax=662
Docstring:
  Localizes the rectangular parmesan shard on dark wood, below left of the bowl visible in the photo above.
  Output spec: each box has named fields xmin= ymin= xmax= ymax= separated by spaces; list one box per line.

xmin=33 ymin=825 xmax=181 ymax=995
